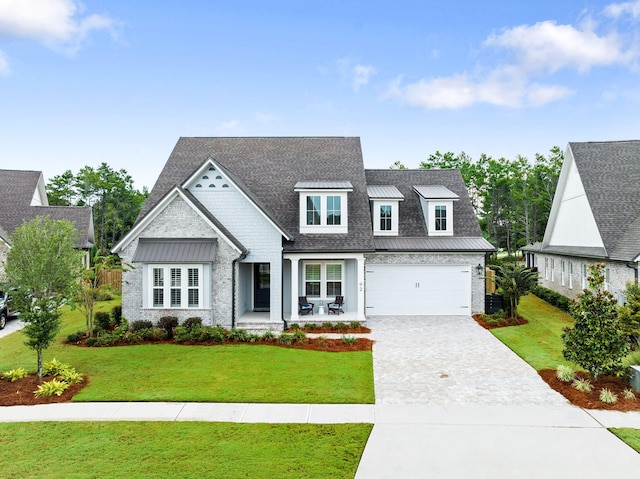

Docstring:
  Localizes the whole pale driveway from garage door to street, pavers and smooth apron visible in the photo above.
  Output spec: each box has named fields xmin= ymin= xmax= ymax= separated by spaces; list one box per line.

xmin=356 ymin=316 xmax=640 ymax=479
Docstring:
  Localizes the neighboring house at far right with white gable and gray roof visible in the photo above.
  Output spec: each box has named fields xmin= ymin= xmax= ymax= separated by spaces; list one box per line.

xmin=523 ymin=140 xmax=640 ymax=300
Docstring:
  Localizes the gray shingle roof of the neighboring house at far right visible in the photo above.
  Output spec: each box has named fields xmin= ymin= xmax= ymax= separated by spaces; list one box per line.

xmin=569 ymin=140 xmax=640 ymax=261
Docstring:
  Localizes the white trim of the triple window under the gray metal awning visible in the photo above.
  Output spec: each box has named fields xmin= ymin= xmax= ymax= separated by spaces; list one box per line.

xmin=146 ymin=263 xmax=205 ymax=310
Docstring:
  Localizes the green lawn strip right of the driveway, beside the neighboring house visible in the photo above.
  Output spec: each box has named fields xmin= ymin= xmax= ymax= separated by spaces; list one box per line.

xmin=491 ymin=294 xmax=573 ymax=371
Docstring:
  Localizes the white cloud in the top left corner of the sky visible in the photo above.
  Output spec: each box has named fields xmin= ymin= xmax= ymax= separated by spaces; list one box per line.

xmin=0 ymin=0 xmax=115 ymax=53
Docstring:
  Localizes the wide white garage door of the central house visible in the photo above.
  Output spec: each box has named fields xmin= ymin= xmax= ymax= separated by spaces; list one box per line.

xmin=366 ymin=264 xmax=471 ymax=316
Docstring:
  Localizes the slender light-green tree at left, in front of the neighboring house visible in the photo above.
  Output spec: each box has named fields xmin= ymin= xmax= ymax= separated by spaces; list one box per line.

xmin=5 ymin=216 xmax=82 ymax=382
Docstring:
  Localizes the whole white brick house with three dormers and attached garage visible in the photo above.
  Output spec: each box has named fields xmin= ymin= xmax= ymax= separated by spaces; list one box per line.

xmin=113 ymin=138 xmax=493 ymax=330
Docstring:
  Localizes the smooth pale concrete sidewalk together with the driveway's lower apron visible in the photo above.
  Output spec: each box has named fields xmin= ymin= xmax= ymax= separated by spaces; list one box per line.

xmin=0 ymin=402 xmax=640 ymax=479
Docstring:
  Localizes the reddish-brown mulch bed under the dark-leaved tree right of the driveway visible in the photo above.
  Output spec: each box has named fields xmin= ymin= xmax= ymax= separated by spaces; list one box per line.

xmin=538 ymin=369 xmax=640 ymax=412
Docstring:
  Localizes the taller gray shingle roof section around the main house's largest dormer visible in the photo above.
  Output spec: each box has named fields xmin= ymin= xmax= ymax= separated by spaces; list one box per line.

xmin=138 ymin=137 xmax=374 ymax=251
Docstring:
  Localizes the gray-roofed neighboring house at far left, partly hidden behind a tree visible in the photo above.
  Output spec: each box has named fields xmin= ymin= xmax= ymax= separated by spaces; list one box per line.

xmin=0 ymin=170 xmax=94 ymax=278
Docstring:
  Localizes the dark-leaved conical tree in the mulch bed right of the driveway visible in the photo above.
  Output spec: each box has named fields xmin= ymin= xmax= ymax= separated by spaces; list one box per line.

xmin=562 ymin=263 xmax=629 ymax=380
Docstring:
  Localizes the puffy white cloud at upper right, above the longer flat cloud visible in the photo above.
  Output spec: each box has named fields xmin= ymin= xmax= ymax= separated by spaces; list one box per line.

xmin=484 ymin=21 xmax=631 ymax=72
